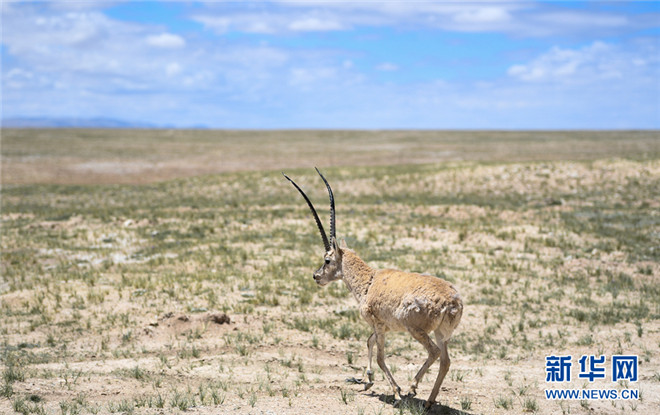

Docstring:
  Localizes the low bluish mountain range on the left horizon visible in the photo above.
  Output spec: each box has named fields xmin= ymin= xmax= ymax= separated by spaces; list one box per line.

xmin=2 ymin=117 xmax=207 ymax=128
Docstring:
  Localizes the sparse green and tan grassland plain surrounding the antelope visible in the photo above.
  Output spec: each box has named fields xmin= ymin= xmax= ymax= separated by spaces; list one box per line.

xmin=0 ymin=130 xmax=660 ymax=415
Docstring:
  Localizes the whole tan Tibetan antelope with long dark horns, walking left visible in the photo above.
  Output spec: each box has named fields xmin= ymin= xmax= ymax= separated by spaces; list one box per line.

xmin=282 ymin=169 xmax=463 ymax=409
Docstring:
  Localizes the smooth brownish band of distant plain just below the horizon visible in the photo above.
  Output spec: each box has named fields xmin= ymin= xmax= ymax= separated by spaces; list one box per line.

xmin=2 ymin=129 xmax=658 ymax=184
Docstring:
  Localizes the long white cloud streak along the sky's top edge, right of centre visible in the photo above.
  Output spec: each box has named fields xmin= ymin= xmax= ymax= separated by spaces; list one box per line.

xmin=191 ymin=0 xmax=660 ymax=36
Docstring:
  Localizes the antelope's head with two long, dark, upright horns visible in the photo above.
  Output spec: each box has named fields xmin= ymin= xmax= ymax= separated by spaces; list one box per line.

xmin=282 ymin=169 xmax=342 ymax=286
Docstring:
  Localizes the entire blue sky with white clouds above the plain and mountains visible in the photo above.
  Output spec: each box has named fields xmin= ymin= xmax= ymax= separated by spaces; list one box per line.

xmin=1 ymin=1 xmax=660 ymax=129
